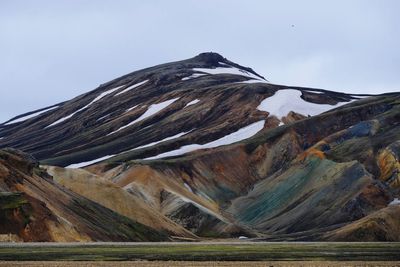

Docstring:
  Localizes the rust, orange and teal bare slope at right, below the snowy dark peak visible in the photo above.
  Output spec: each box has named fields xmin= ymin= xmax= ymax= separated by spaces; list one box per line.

xmin=89 ymin=94 xmax=400 ymax=241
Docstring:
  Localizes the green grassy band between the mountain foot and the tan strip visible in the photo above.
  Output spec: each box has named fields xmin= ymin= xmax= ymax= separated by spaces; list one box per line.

xmin=0 ymin=242 xmax=400 ymax=266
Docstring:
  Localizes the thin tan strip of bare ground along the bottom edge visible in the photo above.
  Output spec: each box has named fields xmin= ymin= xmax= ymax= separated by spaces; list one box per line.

xmin=0 ymin=261 xmax=400 ymax=267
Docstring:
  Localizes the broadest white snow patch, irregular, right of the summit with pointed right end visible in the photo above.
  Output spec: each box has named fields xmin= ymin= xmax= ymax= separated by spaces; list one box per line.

xmin=257 ymin=89 xmax=350 ymax=120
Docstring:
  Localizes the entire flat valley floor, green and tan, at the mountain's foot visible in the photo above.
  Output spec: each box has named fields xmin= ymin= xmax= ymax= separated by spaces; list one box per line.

xmin=0 ymin=244 xmax=400 ymax=267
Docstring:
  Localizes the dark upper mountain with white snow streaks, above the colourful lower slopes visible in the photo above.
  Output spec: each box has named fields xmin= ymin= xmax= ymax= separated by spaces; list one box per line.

xmin=0 ymin=53 xmax=357 ymax=167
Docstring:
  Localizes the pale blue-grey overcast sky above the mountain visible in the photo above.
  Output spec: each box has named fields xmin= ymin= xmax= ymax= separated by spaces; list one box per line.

xmin=0 ymin=0 xmax=400 ymax=121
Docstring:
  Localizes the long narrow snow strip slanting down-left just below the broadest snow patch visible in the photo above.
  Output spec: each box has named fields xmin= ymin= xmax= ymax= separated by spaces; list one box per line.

xmin=146 ymin=120 xmax=265 ymax=160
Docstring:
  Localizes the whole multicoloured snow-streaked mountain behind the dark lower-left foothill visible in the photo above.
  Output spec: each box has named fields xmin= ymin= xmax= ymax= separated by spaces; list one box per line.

xmin=0 ymin=53 xmax=400 ymax=241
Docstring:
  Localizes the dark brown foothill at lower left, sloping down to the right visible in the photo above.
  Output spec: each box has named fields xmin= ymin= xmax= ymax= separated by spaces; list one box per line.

xmin=0 ymin=150 xmax=168 ymax=242
